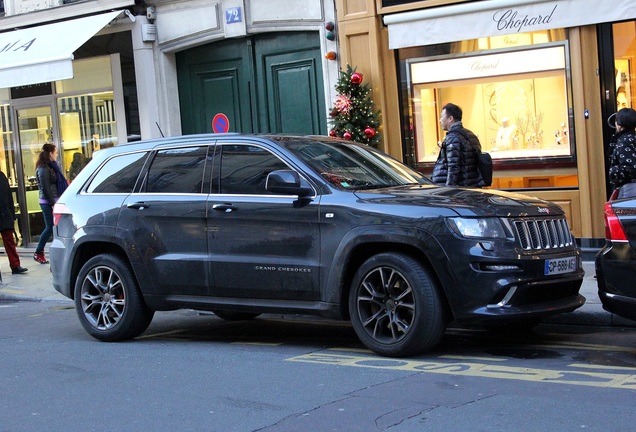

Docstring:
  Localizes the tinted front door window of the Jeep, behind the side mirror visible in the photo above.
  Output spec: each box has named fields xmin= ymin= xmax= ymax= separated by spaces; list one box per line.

xmin=219 ymin=145 xmax=289 ymax=195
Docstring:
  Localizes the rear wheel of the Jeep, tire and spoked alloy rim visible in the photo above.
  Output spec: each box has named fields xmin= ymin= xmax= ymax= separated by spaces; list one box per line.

xmin=75 ymin=254 xmax=154 ymax=342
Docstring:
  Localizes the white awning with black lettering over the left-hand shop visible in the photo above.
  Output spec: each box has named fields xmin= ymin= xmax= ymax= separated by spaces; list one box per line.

xmin=0 ymin=11 xmax=121 ymax=88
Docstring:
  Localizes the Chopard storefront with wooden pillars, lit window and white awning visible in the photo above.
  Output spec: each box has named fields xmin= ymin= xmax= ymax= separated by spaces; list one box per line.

xmin=337 ymin=0 xmax=636 ymax=251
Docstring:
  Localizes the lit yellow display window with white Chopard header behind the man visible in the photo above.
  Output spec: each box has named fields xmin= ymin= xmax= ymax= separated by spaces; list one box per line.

xmin=410 ymin=45 xmax=573 ymax=163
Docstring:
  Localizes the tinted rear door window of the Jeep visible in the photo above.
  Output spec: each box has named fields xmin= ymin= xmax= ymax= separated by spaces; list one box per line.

xmin=146 ymin=145 xmax=208 ymax=193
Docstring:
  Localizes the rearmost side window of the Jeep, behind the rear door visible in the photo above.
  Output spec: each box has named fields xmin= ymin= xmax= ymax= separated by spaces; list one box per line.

xmin=87 ymin=153 xmax=148 ymax=193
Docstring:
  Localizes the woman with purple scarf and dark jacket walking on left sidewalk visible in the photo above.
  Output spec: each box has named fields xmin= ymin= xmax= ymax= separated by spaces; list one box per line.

xmin=33 ymin=144 xmax=68 ymax=264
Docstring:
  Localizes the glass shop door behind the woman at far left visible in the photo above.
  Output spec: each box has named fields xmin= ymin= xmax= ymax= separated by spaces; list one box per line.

xmin=15 ymin=106 xmax=54 ymax=246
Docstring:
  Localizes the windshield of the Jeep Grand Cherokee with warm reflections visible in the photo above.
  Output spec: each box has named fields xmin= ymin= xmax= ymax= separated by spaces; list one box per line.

xmin=279 ymin=138 xmax=432 ymax=189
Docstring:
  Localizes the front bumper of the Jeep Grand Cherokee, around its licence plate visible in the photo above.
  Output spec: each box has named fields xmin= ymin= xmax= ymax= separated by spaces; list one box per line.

xmin=434 ymin=236 xmax=585 ymax=325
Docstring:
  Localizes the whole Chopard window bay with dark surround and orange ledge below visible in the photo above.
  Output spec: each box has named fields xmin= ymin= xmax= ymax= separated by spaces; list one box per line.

xmin=399 ymin=29 xmax=578 ymax=189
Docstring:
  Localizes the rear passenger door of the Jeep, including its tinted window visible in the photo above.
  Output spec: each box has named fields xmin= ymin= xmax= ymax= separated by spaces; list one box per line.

xmin=118 ymin=145 xmax=210 ymax=295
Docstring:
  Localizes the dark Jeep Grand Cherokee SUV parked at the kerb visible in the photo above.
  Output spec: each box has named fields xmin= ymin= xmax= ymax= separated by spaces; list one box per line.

xmin=50 ymin=134 xmax=585 ymax=356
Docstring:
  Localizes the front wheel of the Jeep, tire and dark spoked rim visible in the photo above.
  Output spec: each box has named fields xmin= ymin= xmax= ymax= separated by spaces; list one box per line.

xmin=349 ymin=253 xmax=446 ymax=357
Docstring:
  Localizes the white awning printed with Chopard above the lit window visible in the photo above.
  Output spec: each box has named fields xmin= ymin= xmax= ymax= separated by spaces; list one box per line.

xmin=384 ymin=0 xmax=636 ymax=49
